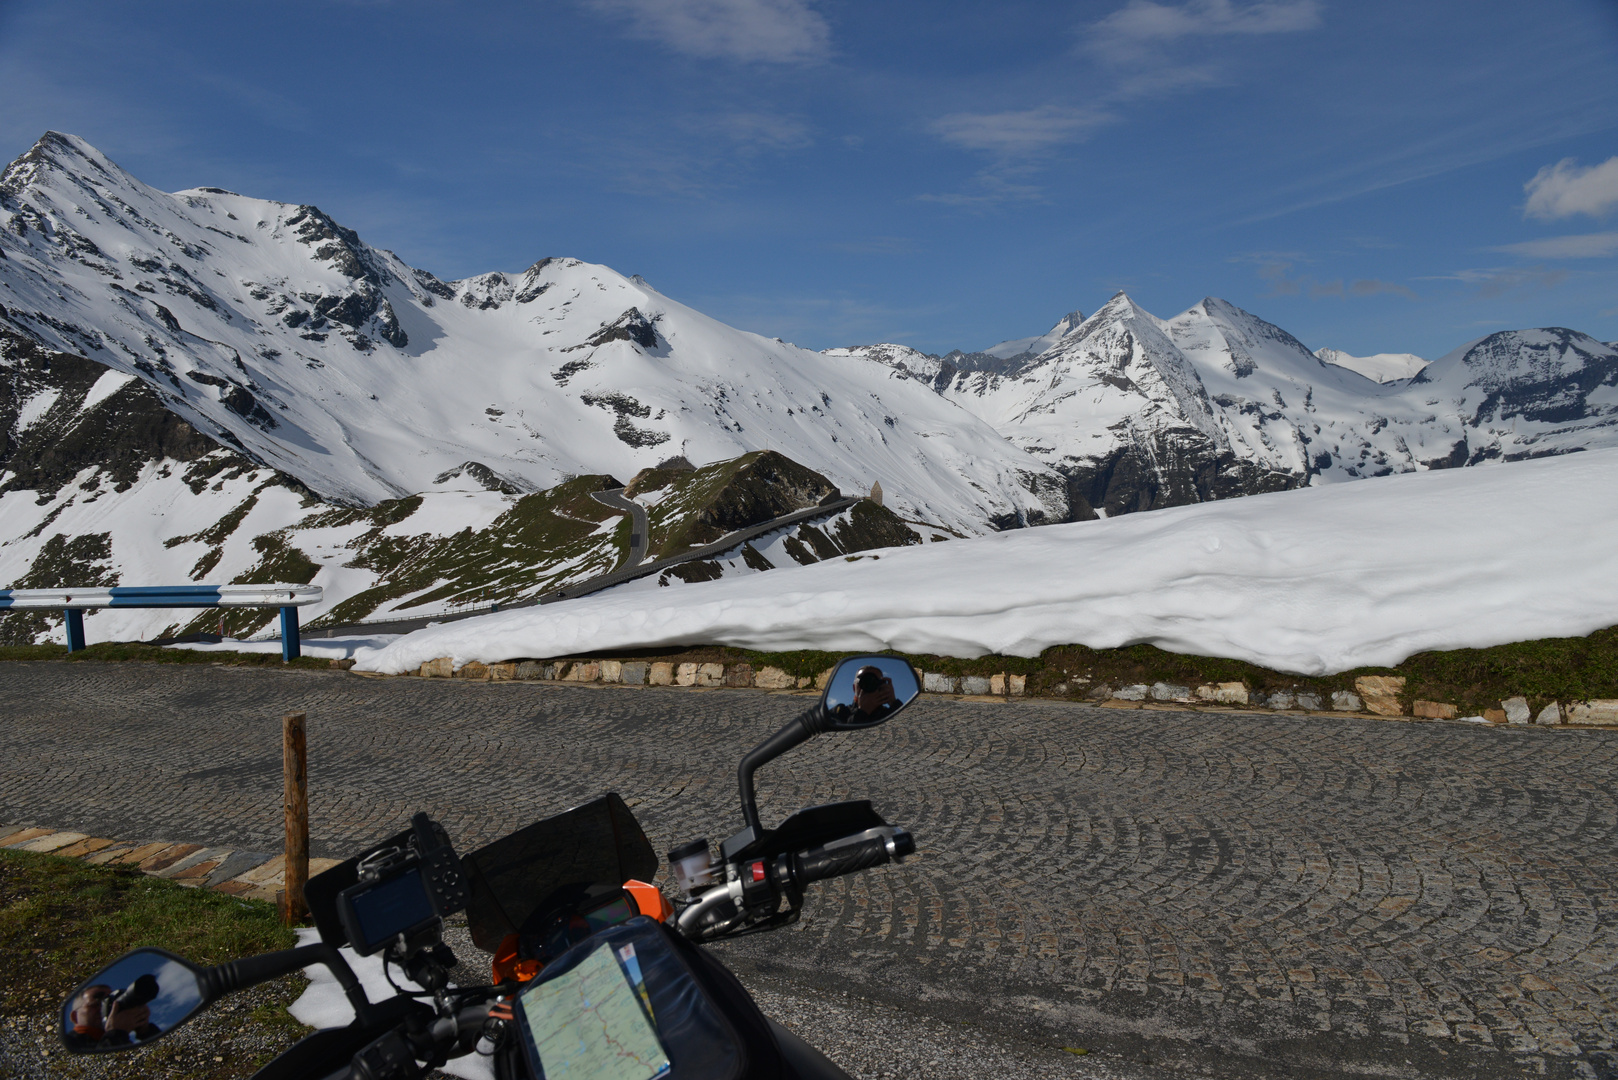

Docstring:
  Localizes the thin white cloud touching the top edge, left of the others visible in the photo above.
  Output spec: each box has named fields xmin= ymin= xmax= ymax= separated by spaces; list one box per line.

xmin=584 ymin=0 xmax=832 ymax=63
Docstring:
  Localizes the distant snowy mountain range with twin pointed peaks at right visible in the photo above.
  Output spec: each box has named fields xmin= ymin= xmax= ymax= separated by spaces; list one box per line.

xmin=841 ymin=293 xmax=1618 ymax=517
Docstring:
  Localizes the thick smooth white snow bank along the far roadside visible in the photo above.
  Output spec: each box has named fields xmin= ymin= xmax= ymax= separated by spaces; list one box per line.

xmin=356 ymin=450 xmax=1618 ymax=675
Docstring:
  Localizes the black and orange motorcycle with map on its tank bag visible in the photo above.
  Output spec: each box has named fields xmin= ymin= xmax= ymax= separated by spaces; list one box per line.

xmin=60 ymin=656 xmax=921 ymax=1080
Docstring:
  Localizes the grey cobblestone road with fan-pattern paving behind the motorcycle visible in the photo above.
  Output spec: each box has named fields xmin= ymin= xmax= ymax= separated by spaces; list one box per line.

xmin=0 ymin=662 xmax=1618 ymax=1077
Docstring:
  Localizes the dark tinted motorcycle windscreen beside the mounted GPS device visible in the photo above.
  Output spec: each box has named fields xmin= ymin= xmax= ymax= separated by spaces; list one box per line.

xmin=461 ymin=793 xmax=659 ymax=952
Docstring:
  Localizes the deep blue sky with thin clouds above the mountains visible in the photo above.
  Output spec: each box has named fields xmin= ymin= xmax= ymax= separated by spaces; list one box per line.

xmin=0 ymin=0 xmax=1618 ymax=356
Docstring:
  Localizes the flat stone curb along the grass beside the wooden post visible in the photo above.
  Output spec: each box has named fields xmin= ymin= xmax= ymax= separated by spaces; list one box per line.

xmin=0 ymin=824 xmax=341 ymax=904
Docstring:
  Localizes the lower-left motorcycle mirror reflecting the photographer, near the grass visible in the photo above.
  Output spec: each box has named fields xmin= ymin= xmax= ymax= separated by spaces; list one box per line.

xmin=61 ymin=949 xmax=207 ymax=1054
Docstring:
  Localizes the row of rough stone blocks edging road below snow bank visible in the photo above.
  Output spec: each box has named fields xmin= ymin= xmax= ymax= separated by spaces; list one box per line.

xmin=385 ymin=656 xmax=1618 ymax=727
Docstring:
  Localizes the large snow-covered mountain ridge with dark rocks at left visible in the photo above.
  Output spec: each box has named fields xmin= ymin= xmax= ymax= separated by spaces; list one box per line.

xmin=0 ymin=133 xmax=1066 ymax=533
